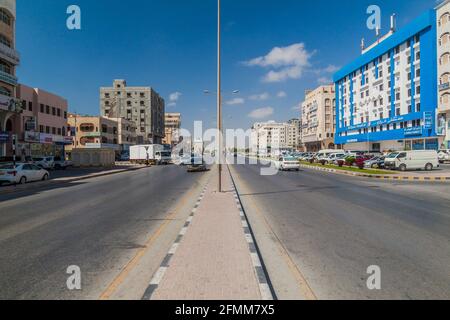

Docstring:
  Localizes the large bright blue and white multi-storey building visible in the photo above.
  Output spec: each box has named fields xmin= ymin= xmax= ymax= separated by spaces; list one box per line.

xmin=332 ymin=10 xmax=438 ymax=152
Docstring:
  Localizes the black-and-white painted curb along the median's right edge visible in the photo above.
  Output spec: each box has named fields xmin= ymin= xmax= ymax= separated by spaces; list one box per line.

xmin=227 ymin=165 xmax=277 ymax=301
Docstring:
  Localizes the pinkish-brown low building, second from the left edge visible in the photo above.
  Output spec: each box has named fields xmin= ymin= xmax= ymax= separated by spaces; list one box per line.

xmin=15 ymin=84 xmax=72 ymax=157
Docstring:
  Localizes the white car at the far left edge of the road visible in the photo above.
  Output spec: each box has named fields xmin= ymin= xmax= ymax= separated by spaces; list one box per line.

xmin=0 ymin=163 xmax=50 ymax=184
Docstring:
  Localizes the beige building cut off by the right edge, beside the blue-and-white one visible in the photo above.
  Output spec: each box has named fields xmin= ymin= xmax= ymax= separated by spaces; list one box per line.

xmin=436 ymin=0 xmax=450 ymax=149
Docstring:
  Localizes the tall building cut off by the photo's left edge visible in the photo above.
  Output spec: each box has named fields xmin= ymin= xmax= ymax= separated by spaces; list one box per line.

xmin=0 ymin=0 xmax=22 ymax=157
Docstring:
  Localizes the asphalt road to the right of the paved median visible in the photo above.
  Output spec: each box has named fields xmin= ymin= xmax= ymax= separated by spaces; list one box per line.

xmin=232 ymin=159 xmax=450 ymax=299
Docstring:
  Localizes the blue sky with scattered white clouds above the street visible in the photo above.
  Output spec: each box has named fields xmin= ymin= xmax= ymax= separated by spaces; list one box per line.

xmin=17 ymin=0 xmax=436 ymax=129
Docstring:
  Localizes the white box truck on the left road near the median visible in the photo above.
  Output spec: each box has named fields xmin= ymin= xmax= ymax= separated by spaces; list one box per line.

xmin=130 ymin=144 xmax=172 ymax=165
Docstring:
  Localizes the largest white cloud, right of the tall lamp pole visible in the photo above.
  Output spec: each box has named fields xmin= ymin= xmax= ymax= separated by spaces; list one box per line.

xmin=245 ymin=43 xmax=314 ymax=82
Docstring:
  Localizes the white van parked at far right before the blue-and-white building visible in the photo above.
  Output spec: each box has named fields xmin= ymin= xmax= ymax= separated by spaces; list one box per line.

xmin=384 ymin=150 xmax=439 ymax=171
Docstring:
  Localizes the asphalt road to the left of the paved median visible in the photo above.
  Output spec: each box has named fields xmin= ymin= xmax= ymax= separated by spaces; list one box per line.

xmin=0 ymin=166 xmax=207 ymax=299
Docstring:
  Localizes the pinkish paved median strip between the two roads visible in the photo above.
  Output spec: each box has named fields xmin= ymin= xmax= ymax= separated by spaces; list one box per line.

xmin=143 ymin=167 xmax=272 ymax=300
